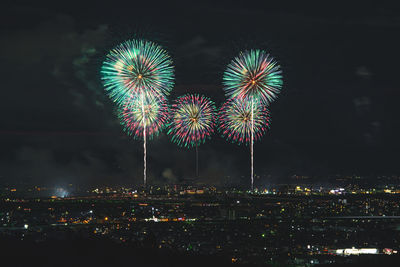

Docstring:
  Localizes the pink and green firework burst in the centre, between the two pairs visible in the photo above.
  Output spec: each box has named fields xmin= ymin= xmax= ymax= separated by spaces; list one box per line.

xmin=168 ymin=94 xmax=215 ymax=147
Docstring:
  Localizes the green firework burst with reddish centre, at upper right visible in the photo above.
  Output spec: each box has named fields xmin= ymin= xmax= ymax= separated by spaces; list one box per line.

xmin=223 ymin=50 xmax=282 ymax=105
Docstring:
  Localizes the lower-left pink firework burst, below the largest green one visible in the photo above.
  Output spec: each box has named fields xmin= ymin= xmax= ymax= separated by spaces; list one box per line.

xmin=118 ymin=95 xmax=168 ymax=140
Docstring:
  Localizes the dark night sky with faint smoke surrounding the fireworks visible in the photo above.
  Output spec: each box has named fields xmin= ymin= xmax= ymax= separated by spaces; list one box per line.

xmin=0 ymin=1 xmax=400 ymax=184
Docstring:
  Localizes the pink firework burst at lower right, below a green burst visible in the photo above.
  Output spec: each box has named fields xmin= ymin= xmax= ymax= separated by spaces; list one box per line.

xmin=219 ymin=98 xmax=270 ymax=145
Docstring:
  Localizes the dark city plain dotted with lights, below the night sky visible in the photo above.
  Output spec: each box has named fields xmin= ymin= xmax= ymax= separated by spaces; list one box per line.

xmin=0 ymin=193 xmax=400 ymax=266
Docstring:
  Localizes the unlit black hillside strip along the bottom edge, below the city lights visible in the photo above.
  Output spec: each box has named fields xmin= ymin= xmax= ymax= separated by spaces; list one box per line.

xmin=0 ymin=239 xmax=400 ymax=267
